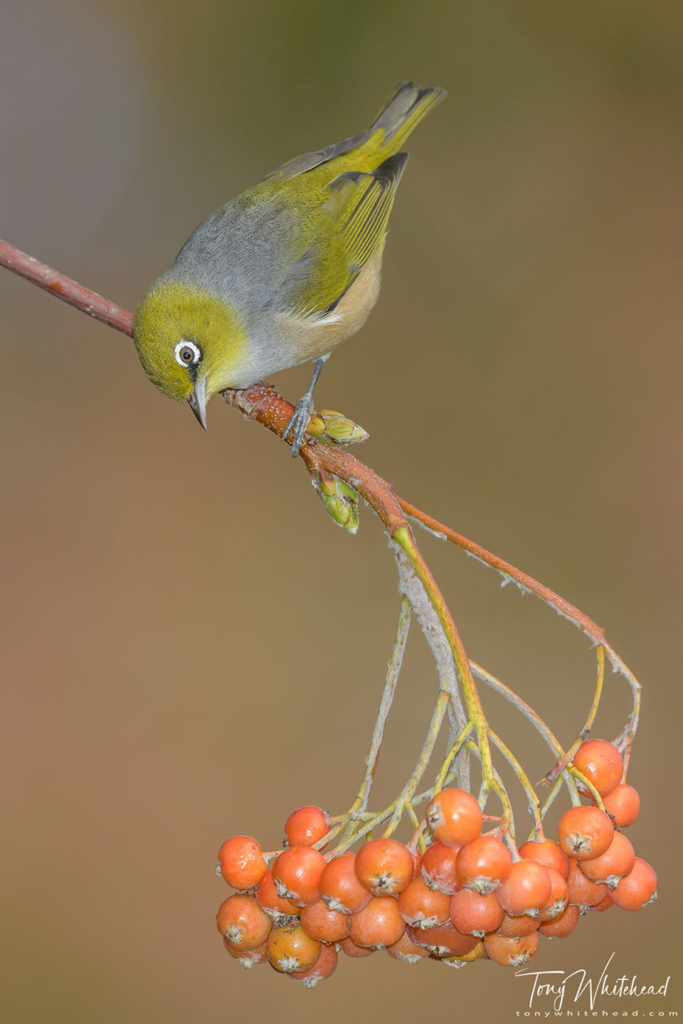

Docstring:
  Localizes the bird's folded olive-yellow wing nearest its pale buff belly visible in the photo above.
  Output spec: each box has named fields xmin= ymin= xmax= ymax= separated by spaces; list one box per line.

xmin=288 ymin=153 xmax=408 ymax=316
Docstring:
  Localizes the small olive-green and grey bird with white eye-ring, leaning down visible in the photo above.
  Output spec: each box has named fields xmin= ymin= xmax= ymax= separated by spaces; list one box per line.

xmin=133 ymin=82 xmax=445 ymax=456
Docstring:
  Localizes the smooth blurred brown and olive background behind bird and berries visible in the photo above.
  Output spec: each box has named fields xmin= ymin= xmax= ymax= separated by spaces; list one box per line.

xmin=0 ymin=0 xmax=683 ymax=1024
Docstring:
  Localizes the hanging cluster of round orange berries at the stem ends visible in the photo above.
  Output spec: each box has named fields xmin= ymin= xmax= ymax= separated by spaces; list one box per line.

xmin=217 ymin=740 xmax=656 ymax=987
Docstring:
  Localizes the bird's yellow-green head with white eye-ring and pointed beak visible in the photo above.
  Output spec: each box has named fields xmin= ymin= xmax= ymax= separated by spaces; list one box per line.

xmin=133 ymin=278 xmax=247 ymax=430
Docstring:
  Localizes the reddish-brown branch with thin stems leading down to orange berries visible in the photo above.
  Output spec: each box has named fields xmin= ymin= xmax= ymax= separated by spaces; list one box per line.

xmin=0 ymin=234 xmax=641 ymax=864
